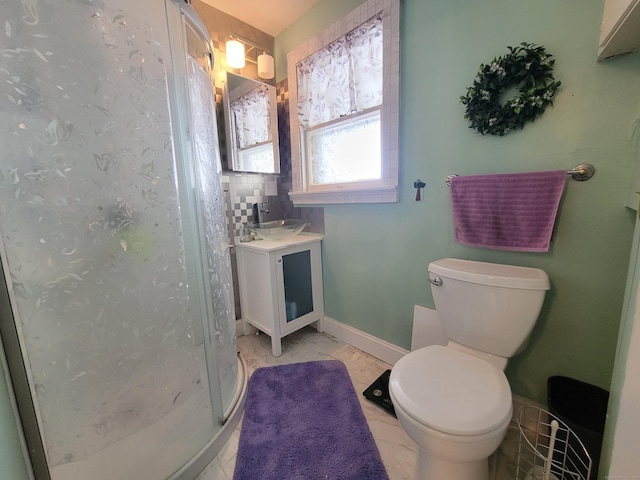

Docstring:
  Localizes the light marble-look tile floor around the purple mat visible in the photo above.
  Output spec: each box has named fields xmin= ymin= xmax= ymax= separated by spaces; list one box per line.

xmin=197 ymin=327 xmax=517 ymax=480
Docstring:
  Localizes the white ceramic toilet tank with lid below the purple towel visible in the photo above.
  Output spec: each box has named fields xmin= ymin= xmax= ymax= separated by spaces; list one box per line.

xmin=429 ymin=258 xmax=549 ymax=358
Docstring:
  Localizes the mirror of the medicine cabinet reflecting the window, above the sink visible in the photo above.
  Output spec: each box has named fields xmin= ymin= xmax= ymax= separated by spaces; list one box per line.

xmin=222 ymin=72 xmax=280 ymax=173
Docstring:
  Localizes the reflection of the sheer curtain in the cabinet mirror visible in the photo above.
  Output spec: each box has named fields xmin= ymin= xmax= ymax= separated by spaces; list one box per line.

xmin=230 ymin=85 xmax=271 ymax=149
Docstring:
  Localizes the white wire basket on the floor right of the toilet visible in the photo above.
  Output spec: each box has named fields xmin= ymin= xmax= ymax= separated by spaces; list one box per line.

xmin=516 ymin=407 xmax=591 ymax=480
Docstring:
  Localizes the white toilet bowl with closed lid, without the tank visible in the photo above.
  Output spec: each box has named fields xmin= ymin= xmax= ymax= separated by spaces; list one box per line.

xmin=389 ymin=345 xmax=512 ymax=480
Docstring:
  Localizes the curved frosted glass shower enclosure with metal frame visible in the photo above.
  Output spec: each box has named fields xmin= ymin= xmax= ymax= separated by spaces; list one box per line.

xmin=0 ymin=0 xmax=245 ymax=480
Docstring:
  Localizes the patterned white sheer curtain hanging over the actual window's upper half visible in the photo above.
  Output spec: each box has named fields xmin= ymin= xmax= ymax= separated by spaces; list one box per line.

xmin=296 ymin=16 xmax=382 ymax=127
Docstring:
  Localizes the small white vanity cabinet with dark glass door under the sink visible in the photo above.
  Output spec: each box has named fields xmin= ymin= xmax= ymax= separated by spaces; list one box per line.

xmin=236 ymin=235 xmax=324 ymax=357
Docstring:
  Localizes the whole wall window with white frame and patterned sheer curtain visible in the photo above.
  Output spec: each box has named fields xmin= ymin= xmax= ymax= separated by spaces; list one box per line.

xmin=287 ymin=0 xmax=400 ymax=204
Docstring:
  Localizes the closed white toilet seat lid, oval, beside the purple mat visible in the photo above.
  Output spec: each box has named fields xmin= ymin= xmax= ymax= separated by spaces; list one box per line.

xmin=389 ymin=345 xmax=512 ymax=435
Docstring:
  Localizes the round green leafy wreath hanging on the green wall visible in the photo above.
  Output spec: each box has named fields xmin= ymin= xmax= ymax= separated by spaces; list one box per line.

xmin=460 ymin=42 xmax=560 ymax=136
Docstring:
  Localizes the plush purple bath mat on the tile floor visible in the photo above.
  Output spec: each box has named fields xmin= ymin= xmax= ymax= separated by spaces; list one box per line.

xmin=233 ymin=360 xmax=389 ymax=480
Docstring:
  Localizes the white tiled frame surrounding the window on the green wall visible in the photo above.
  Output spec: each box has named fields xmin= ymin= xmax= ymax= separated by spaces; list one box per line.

xmin=287 ymin=0 xmax=400 ymax=205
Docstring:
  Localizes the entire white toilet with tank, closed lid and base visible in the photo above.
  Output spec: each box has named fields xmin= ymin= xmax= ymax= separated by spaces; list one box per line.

xmin=389 ymin=258 xmax=549 ymax=480
